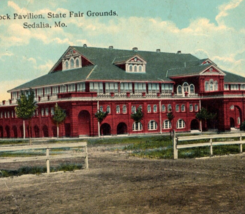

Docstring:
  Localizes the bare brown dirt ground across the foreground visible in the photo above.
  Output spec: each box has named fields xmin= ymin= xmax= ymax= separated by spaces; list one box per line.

xmin=0 ymin=147 xmax=245 ymax=214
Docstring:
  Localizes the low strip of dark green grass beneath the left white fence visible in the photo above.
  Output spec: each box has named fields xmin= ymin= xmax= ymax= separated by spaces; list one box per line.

xmin=0 ymin=164 xmax=83 ymax=177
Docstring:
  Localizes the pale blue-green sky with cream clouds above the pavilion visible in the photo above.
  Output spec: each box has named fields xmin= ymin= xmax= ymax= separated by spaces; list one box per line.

xmin=0 ymin=0 xmax=245 ymax=100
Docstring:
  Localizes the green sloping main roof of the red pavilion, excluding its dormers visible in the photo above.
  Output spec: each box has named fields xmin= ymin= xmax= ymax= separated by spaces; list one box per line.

xmin=8 ymin=46 xmax=245 ymax=91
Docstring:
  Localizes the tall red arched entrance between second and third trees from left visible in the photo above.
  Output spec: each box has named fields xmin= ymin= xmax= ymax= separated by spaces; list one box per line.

xmin=78 ymin=110 xmax=90 ymax=136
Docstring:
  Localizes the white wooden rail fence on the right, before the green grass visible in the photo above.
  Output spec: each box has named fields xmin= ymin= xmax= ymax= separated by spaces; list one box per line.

xmin=173 ymin=133 xmax=245 ymax=159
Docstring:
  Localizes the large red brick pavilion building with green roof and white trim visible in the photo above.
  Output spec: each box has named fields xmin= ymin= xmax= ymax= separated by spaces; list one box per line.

xmin=0 ymin=45 xmax=245 ymax=138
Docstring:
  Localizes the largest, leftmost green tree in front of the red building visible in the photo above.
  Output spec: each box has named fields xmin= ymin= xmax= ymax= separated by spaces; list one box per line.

xmin=15 ymin=88 xmax=37 ymax=144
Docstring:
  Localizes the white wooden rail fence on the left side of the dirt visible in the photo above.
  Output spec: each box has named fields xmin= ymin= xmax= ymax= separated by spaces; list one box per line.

xmin=0 ymin=142 xmax=88 ymax=174
